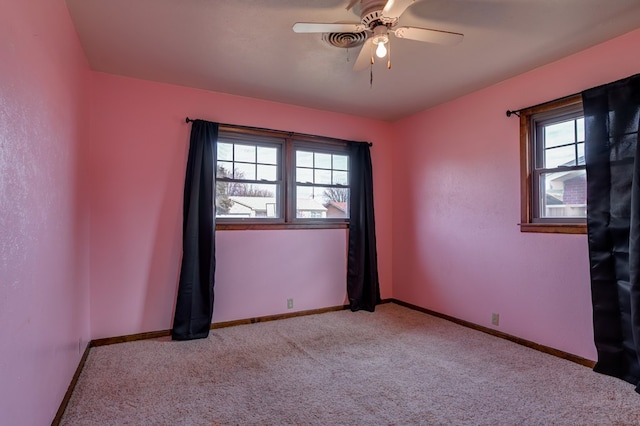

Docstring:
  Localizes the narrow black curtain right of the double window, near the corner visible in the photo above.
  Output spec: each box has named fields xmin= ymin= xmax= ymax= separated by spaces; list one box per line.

xmin=347 ymin=143 xmax=380 ymax=312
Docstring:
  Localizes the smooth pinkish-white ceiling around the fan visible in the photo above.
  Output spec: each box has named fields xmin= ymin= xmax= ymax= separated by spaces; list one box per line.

xmin=66 ymin=0 xmax=640 ymax=121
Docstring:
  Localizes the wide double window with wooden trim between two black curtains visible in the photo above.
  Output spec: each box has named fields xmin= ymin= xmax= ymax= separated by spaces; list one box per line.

xmin=215 ymin=125 xmax=349 ymax=229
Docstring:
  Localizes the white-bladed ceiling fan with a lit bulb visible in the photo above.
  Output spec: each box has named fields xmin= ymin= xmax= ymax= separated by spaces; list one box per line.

xmin=293 ymin=0 xmax=464 ymax=71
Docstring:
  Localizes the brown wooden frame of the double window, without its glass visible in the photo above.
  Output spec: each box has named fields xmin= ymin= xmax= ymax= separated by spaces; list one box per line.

xmin=214 ymin=125 xmax=351 ymax=230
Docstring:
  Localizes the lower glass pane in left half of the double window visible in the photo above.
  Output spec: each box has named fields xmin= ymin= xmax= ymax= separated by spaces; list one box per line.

xmin=216 ymin=182 xmax=282 ymax=218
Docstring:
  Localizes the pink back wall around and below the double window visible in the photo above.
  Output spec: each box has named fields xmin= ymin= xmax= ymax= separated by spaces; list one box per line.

xmin=89 ymin=73 xmax=392 ymax=338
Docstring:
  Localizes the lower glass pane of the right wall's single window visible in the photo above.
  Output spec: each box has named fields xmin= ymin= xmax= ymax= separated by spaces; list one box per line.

xmin=539 ymin=170 xmax=587 ymax=218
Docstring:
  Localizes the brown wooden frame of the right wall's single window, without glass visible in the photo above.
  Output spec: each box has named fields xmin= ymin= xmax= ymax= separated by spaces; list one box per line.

xmin=520 ymin=94 xmax=587 ymax=234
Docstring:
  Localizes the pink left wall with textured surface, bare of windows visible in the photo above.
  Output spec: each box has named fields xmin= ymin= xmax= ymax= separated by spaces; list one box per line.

xmin=0 ymin=0 xmax=89 ymax=425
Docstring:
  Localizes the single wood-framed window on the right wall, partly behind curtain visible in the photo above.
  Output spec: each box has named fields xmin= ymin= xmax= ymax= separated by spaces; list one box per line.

xmin=520 ymin=95 xmax=587 ymax=233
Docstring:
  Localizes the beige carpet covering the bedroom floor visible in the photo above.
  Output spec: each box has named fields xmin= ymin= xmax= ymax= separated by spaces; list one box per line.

xmin=62 ymin=304 xmax=640 ymax=425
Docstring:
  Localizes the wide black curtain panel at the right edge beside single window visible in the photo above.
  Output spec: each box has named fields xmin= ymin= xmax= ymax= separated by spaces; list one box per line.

xmin=582 ymin=74 xmax=640 ymax=392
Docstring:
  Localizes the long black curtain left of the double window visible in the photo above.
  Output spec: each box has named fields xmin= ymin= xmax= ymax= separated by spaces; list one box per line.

xmin=171 ymin=120 xmax=218 ymax=340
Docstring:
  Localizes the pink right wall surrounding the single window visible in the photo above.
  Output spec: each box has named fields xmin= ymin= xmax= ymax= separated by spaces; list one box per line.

xmin=393 ymin=30 xmax=640 ymax=359
